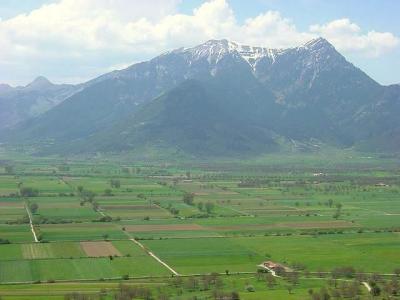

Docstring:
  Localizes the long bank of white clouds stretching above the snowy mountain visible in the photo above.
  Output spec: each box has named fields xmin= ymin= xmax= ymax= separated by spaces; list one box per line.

xmin=0 ymin=0 xmax=399 ymax=81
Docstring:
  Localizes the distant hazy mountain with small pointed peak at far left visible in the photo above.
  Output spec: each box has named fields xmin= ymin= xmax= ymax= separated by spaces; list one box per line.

xmin=0 ymin=77 xmax=78 ymax=129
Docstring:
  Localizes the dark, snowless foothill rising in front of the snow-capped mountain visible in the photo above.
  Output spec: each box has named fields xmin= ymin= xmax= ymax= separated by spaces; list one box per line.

xmin=80 ymin=80 xmax=278 ymax=156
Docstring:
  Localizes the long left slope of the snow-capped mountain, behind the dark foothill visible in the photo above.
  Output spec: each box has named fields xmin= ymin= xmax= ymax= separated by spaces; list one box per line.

xmin=6 ymin=39 xmax=268 ymax=142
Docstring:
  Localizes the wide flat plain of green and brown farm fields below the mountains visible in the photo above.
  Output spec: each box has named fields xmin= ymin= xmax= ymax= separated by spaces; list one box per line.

xmin=0 ymin=153 xmax=400 ymax=299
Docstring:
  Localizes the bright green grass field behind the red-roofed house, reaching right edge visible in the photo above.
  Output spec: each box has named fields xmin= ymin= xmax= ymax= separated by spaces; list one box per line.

xmin=233 ymin=233 xmax=400 ymax=273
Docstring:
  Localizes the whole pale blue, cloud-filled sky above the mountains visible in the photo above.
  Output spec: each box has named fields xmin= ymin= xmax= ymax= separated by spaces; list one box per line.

xmin=0 ymin=0 xmax=400 ymax=86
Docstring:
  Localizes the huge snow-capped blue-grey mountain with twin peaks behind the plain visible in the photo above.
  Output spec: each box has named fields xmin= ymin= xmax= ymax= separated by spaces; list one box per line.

xmin=0 ymin=38 xmax=400 ymax=157
